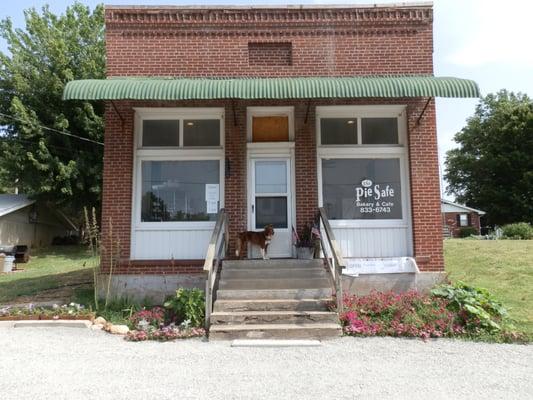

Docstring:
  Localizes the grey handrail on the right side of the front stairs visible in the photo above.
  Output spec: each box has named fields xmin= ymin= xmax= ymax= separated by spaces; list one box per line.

xmin=318 ymin=207 xmax=346 ymax=313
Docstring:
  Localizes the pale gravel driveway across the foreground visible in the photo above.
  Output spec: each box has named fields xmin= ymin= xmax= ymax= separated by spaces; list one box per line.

xmin=0 ymin=328 xmax=533 ymax=400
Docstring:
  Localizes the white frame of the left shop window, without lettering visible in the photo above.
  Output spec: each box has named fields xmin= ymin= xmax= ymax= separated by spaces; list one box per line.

xmin=131 ymin=107 xmax=225 ymax=231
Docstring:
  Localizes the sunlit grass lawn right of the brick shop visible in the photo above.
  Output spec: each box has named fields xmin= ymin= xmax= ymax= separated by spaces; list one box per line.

xmin=444 ymin=239 xmax=533 ymax=338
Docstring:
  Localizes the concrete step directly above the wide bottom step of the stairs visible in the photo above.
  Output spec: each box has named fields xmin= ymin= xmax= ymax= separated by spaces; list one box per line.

xmin=211 ymin=311 xmax=339 ymax=325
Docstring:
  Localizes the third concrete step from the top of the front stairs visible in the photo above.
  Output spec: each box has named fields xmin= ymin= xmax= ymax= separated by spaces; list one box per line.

xmin=218 ymin=278 xmax=331 ymax=290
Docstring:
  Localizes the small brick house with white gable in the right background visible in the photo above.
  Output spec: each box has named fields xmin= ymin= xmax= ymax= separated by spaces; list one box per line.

xmin=440 ymin=199 xmax=485 ymax=237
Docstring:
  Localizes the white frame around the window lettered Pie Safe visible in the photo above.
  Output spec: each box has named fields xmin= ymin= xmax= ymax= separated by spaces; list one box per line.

xmin=316 ymin=105 xmax=411 ymax=230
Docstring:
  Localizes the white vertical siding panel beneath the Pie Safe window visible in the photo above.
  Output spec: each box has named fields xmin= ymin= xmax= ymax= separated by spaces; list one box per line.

xmin=333 ymin=227 xmax=412 ymax=258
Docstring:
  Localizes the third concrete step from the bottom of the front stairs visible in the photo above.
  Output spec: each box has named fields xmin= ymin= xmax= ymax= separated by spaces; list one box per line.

xmin=213 ymin=298 xmax=334 ymax=312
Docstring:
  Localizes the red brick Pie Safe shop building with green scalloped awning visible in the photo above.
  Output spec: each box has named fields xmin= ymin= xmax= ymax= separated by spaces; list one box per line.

xmin=64 ymin=3 xmax=479 ymax=304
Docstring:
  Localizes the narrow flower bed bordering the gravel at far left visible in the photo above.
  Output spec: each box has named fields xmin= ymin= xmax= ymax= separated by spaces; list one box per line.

xmin=0 ymin=303 xmax=95 ymax=321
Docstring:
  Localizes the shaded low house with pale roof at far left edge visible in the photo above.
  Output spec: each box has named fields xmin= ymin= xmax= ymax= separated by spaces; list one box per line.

xmin=0 ymin=194 xmax=77 ymax=247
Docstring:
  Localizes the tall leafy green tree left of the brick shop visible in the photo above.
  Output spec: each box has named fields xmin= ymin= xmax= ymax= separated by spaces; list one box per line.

xmin=0 ymin=3 xmax=105 ymax=219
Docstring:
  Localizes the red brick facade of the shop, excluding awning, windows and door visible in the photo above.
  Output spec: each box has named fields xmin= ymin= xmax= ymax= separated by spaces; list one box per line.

xmin=102 ymin=6 xmax=443 ymax=274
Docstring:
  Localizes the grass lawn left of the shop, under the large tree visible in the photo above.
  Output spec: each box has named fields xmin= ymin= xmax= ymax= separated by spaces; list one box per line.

xmin=0 ymin=246 xmax=93 ymax=304
